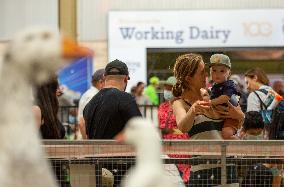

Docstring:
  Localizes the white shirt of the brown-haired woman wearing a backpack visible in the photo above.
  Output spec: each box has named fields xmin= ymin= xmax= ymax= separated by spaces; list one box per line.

xmin=247 ymin=85 xmax=272 ymax=112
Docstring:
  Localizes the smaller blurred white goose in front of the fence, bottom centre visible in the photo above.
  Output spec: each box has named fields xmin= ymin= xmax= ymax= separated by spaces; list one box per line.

xmin=115 ymin=117 xmax=176 ymax=187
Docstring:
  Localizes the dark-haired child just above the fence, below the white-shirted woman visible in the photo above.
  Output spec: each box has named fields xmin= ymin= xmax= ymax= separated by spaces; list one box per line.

xmin=241 ymin=111 xmax=264 ymax=140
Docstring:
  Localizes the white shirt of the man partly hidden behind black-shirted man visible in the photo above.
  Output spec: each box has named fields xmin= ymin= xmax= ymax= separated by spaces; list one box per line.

xmin=78 ymin=86 xmax=99 ymax=120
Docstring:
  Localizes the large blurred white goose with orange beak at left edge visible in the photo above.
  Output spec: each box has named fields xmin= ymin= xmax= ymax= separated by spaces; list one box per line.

xmin=0 ymin=27 xmax=90 ymax=187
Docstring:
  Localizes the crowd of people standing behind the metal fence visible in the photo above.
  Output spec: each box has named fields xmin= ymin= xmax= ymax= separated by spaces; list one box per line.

xmin=33 ymin=53 xmax=284 ymax=185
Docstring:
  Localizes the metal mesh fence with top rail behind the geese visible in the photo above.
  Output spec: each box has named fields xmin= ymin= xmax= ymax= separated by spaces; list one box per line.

xmin=43 ymin=140 xmax=284 ymax=187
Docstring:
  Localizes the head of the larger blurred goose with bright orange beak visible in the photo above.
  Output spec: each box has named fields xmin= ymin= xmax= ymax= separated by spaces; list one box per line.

xmin=3 ymin=27 xmax=91 ymax=84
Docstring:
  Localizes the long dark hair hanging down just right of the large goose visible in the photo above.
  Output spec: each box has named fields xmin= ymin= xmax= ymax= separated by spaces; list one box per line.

xmin=35 ymin=78 xmax=62 ymax=139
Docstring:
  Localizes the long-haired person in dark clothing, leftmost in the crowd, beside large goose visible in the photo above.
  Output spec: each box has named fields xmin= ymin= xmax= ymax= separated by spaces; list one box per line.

xmin=33 ymin=78 xmax=65 ymax=139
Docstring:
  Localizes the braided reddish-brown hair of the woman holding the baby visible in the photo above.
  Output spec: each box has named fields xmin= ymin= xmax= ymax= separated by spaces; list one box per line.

xmin=172 ymin=53 xmax=203 ymax=97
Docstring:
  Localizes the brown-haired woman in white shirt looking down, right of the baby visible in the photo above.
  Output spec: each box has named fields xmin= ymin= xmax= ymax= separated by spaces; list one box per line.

xmin=245 ymin=68 xmax=272 ymax=112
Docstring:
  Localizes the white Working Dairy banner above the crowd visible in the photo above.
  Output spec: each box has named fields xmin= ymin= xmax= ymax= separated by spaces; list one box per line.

xmin=108 ymin=9 xmax=284 ymax=90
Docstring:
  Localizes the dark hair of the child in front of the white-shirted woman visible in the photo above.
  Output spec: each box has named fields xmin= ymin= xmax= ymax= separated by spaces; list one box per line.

xmin=243 ymin=111 xmax=264 ymax=130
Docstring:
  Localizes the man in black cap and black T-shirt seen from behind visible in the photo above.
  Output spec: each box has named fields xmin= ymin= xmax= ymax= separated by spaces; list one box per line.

xmin=83 ymin=60 xmax=141 ymax=139
